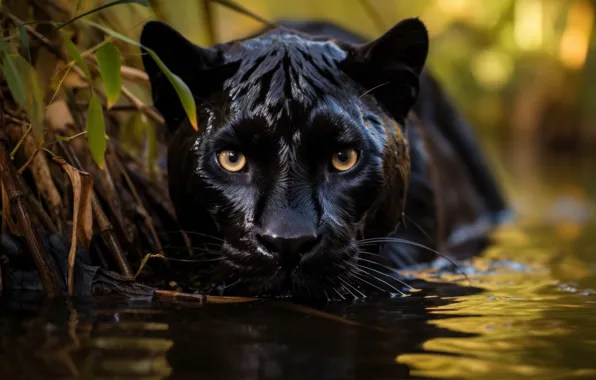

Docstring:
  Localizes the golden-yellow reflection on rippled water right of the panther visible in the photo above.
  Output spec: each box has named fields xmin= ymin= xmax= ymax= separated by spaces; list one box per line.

xmin=396 ymin=219 xmax=596 ymax=379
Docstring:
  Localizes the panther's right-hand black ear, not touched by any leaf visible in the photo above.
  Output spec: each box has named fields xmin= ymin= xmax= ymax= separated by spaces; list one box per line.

xmin=342 ymin=18 xmax=429 ymax=123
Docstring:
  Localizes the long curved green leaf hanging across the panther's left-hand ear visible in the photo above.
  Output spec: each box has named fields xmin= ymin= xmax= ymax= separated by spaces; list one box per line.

xmin=86 ymin=20 xmax=199 ymax=131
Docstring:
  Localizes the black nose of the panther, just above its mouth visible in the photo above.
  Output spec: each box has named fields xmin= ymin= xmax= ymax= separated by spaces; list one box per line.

xmin=257 ymin=233 xmax=319 ymax=267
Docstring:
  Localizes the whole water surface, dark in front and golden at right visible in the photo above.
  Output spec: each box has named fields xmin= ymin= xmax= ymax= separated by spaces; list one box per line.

xmin=0 ymin=150 xmax=596 ymax=380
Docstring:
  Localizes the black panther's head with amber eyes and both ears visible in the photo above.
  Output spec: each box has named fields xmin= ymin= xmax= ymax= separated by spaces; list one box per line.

xmin=141 ymin=18 xmax=428 ymax=296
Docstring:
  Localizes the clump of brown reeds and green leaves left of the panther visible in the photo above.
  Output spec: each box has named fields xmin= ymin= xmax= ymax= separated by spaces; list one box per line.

xmin=0 ymin=0 xmax=207 ymax=295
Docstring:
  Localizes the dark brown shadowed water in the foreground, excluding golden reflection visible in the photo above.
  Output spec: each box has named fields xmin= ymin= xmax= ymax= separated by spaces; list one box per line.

xmin=0 ymin=283 xmax=479 ymax=379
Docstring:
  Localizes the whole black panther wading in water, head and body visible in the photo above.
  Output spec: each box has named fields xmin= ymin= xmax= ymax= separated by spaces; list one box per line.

xmin=0 ymin=18 xmax=507 ymax=299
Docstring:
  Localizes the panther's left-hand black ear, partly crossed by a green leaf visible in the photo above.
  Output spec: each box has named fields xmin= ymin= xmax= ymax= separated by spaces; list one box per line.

xmin=140 ymin=21 xmax=218 ymax=130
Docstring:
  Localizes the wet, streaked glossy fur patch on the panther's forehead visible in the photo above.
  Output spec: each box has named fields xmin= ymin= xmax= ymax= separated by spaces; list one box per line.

xmin=224 ymin=29 xmax=350 ymax=123
